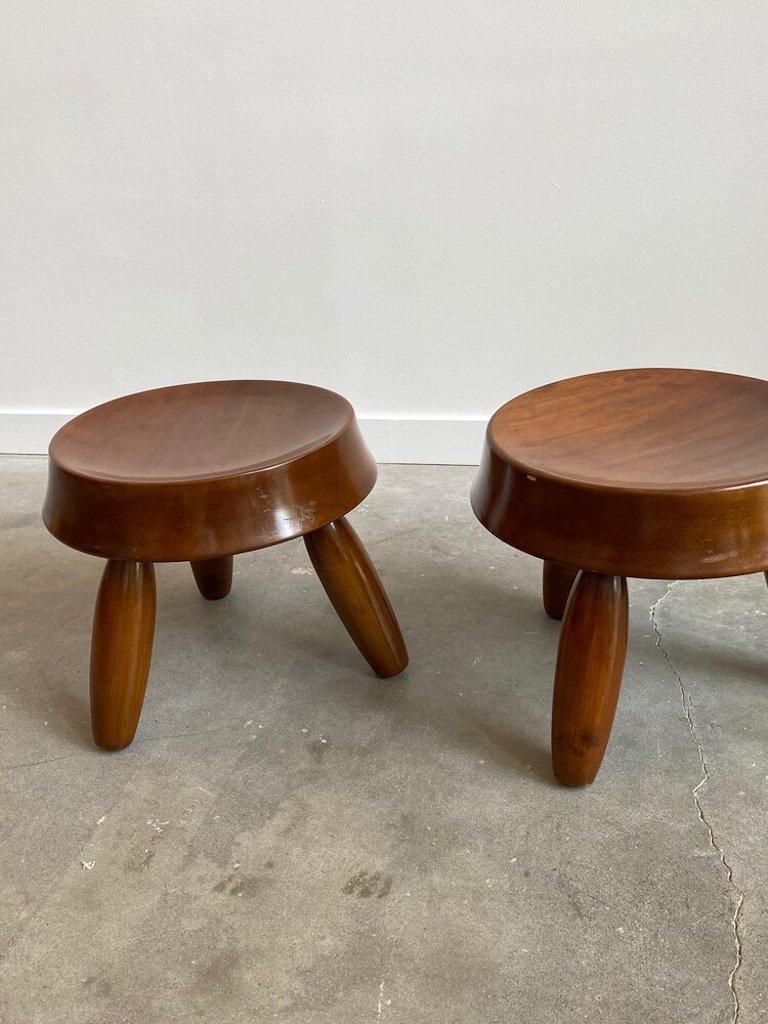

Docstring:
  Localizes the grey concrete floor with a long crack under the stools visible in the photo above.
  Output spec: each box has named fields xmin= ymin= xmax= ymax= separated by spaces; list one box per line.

xmin=0 ymin=458 xmax=768 ymax=1024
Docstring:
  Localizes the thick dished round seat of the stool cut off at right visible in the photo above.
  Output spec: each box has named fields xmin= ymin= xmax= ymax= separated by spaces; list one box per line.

xmin=472 ymin=369 xmax=768 ymax=579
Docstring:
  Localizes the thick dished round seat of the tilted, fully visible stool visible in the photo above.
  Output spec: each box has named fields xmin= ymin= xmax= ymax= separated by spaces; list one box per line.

xmin=43 ymin=381 xmax=376 ymax=562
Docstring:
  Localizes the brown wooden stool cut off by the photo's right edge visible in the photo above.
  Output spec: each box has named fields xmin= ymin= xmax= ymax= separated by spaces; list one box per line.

xmin=472 ymin=370 xmax=768 ymax=785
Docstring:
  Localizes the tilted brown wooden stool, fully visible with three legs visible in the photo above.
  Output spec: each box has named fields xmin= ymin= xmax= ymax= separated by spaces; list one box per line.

xmin=43 ymin=381 xmax=408 ymax=750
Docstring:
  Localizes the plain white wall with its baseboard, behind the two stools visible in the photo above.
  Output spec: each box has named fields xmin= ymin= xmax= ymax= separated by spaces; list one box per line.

xmin=0 ymin=0 xmax=768 ymax=461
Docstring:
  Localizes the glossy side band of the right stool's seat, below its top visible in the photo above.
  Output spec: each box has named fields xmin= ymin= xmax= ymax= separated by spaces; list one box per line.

xmin=471 ymin=433 xmax=768 ymax=580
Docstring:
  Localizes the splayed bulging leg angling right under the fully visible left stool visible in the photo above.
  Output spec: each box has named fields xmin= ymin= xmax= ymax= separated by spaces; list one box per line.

xmin=304 ymin=516 xmax=408 ymax=679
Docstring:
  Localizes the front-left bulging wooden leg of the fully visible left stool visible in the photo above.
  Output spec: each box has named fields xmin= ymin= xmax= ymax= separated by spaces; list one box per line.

xmin=91 ymin=561 xmax=156 ymax=751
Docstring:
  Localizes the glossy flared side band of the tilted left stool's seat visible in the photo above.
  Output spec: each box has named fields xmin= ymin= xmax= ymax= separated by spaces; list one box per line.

xmin=43 ymin=406 xmax=378 ymax=562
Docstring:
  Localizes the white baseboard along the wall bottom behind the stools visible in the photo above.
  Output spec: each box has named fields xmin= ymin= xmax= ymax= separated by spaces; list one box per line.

xmin=0 ymin=410 xmax=486 ymax=466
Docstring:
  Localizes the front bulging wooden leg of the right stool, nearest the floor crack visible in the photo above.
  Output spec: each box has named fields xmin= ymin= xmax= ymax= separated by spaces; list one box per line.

xmin=552 ymin=571 xmax=627 ymax=785
